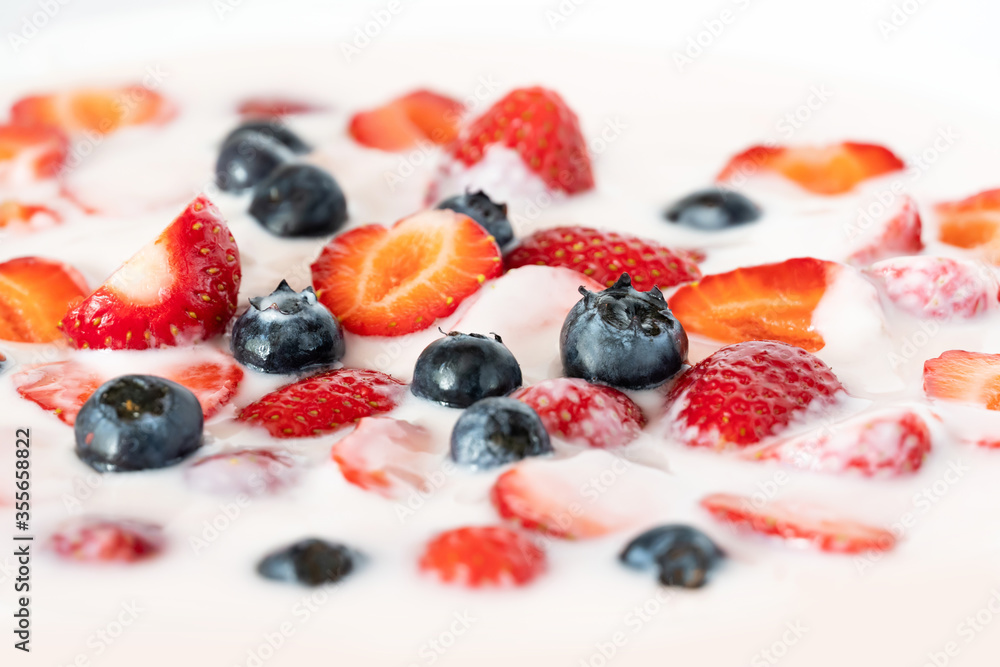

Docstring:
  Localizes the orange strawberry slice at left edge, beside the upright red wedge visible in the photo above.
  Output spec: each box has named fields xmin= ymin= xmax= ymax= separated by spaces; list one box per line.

xmin=0 ymin=257 xmax=87 ymax=343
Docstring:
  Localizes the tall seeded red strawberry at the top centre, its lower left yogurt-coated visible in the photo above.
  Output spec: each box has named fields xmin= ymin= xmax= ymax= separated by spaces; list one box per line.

xmin=451 ymin=87 xmax=594 ymax=194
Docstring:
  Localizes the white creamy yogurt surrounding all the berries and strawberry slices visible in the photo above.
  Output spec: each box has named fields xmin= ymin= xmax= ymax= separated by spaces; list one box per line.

xmin=0 ymin=45 xmax=1000 ymax=667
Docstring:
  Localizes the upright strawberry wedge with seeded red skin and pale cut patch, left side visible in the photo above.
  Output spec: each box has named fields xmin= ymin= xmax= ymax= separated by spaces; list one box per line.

xmin=61 ymin=195 xmax=240 ymax=350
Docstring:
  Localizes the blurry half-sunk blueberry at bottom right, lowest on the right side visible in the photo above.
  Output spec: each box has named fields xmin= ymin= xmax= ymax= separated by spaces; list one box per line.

xmin=619 ymin=525 xmax=725 ymax=588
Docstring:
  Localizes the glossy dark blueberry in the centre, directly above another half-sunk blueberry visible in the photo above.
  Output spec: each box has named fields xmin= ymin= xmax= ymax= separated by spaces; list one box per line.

xmin=410 ymin=331 xmax=521 ymax=408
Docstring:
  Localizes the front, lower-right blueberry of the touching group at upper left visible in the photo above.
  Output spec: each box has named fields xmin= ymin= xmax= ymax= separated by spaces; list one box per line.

xmin=250 ymin=164 xmax=347 ymax=236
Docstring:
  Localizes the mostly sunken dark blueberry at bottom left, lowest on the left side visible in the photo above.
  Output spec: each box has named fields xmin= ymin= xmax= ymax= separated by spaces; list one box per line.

xmin=257 ymin=538 xmax=360 ymax=586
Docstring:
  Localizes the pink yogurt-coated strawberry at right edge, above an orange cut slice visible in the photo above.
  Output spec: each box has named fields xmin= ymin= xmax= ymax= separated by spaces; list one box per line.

xmin=865 ymin=256 xmax=1000 ymax=320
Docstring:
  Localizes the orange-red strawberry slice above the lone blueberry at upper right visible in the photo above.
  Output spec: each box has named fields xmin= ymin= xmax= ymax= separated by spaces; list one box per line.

xmin=716 ymin=141 xmax=906 ymax=195
